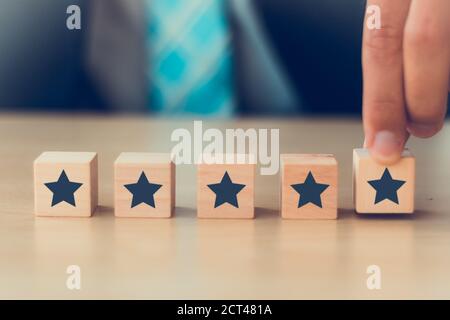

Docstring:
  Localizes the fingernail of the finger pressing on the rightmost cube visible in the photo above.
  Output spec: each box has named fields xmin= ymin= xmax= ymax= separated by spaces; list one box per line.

xmin=372 ymin=131 xmax=403 ymax=162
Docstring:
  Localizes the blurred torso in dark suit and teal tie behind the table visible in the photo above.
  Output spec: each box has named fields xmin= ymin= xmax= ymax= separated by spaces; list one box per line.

xmin=0 ymin=0 xmax=365 ymax=117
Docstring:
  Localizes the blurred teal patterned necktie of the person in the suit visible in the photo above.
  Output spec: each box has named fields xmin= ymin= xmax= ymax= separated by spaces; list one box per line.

xmin=145 ymin=0 xmax=235 ymax=116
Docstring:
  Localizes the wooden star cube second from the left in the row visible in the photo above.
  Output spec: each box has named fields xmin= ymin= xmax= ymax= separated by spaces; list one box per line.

xmin=114 ymin=152 xmax=175 ymax=218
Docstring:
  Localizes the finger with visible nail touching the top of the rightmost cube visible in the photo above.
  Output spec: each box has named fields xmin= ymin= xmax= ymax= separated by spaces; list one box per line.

xmin=363 ymin=0 xmax=410 ymax=164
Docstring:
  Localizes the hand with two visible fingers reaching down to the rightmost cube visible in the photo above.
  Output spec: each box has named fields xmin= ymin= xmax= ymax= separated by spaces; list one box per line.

xmin=363 ymin=0 xmax=450 ymax=165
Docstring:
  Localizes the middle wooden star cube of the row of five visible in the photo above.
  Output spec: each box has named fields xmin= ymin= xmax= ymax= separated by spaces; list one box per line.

xmin=197 ymin=154 xmax=256 ymax=219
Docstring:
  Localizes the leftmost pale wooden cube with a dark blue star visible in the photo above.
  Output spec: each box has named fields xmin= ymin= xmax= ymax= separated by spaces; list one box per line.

xmin=34 ymin=152 xmax=98 ymax=217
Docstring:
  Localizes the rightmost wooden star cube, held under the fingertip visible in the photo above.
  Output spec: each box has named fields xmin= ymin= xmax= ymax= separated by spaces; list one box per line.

xmin=353 ymin=149 xmax=415 ymax=214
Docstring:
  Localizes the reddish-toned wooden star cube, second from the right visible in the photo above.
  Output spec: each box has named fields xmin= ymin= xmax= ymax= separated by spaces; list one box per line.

xmin=280 ymin=154 xmax=338 ymax=219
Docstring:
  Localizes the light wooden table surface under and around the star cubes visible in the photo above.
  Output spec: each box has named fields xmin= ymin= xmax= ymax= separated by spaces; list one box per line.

xmin=0 ymin=114 xmax=450 ymax=299
